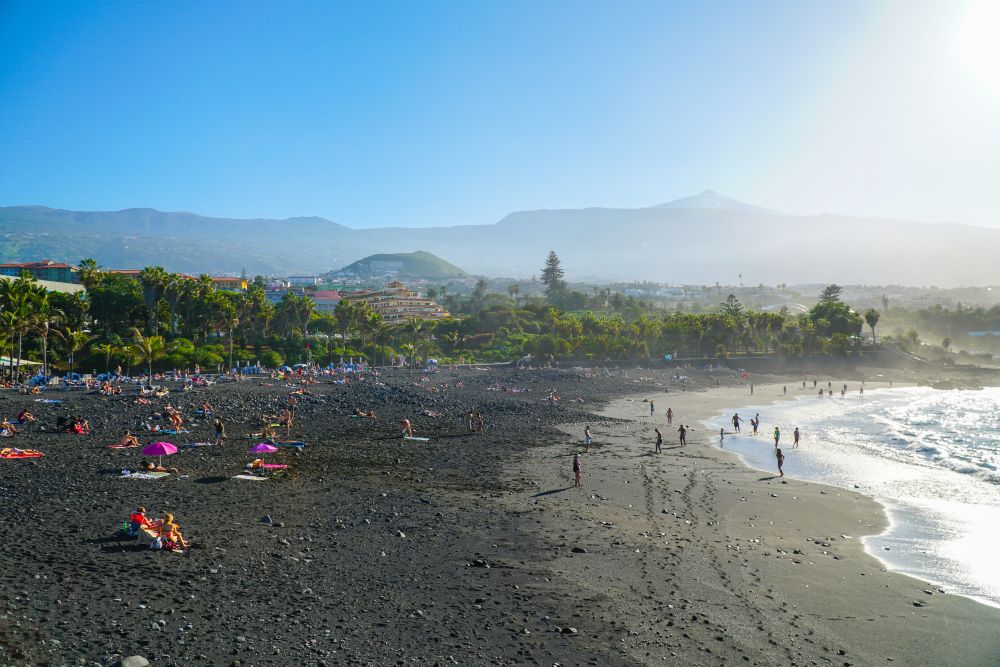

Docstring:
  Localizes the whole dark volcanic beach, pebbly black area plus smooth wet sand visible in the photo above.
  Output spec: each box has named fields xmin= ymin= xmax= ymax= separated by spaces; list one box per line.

xmin=0 ymin=369 xmax=1000 ymax=665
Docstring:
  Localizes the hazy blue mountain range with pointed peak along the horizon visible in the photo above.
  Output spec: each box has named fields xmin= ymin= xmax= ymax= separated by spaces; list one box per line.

xmin=0 ymin=190 xmax=1000 ymax=287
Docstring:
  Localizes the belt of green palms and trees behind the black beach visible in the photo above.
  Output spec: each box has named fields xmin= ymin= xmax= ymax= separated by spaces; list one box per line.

xmin=0 ymin=252 xmax=900 ymax=373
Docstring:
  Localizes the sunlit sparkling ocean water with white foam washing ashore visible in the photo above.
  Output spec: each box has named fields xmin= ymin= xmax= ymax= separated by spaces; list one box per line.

xmin=705 ymin=385 xmax=1000 ymax=606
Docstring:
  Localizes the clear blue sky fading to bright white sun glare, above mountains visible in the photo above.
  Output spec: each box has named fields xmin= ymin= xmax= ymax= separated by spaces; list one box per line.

xmin=0 ymin=0 xmax=1000 ymax=227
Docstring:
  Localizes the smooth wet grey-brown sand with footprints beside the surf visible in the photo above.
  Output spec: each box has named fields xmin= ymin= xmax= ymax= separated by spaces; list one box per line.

xmin=511 ymin=382 xmax=1000 ymax=665
